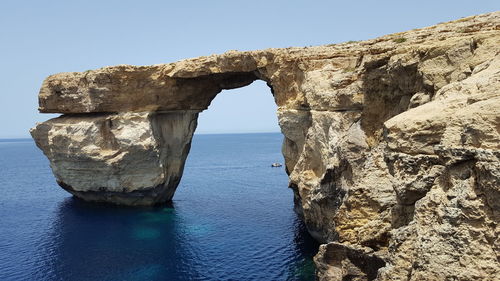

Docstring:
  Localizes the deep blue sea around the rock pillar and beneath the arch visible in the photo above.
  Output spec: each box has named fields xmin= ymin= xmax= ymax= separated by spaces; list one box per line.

xmin=0 ymin=134 xmax=317 ymax=280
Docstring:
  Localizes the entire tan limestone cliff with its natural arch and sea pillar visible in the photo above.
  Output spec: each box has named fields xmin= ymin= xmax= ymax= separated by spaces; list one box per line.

xmin=31 ymin=12 xmax=500 ymax=280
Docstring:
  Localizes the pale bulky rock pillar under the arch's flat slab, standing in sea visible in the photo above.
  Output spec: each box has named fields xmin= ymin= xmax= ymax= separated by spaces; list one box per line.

xmin=32 ymin=111 xmax=198 ymax=206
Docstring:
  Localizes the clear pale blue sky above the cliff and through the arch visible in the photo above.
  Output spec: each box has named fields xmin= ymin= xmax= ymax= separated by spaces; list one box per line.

xmin=0 ymin=0 xmax=500 ymax=138
